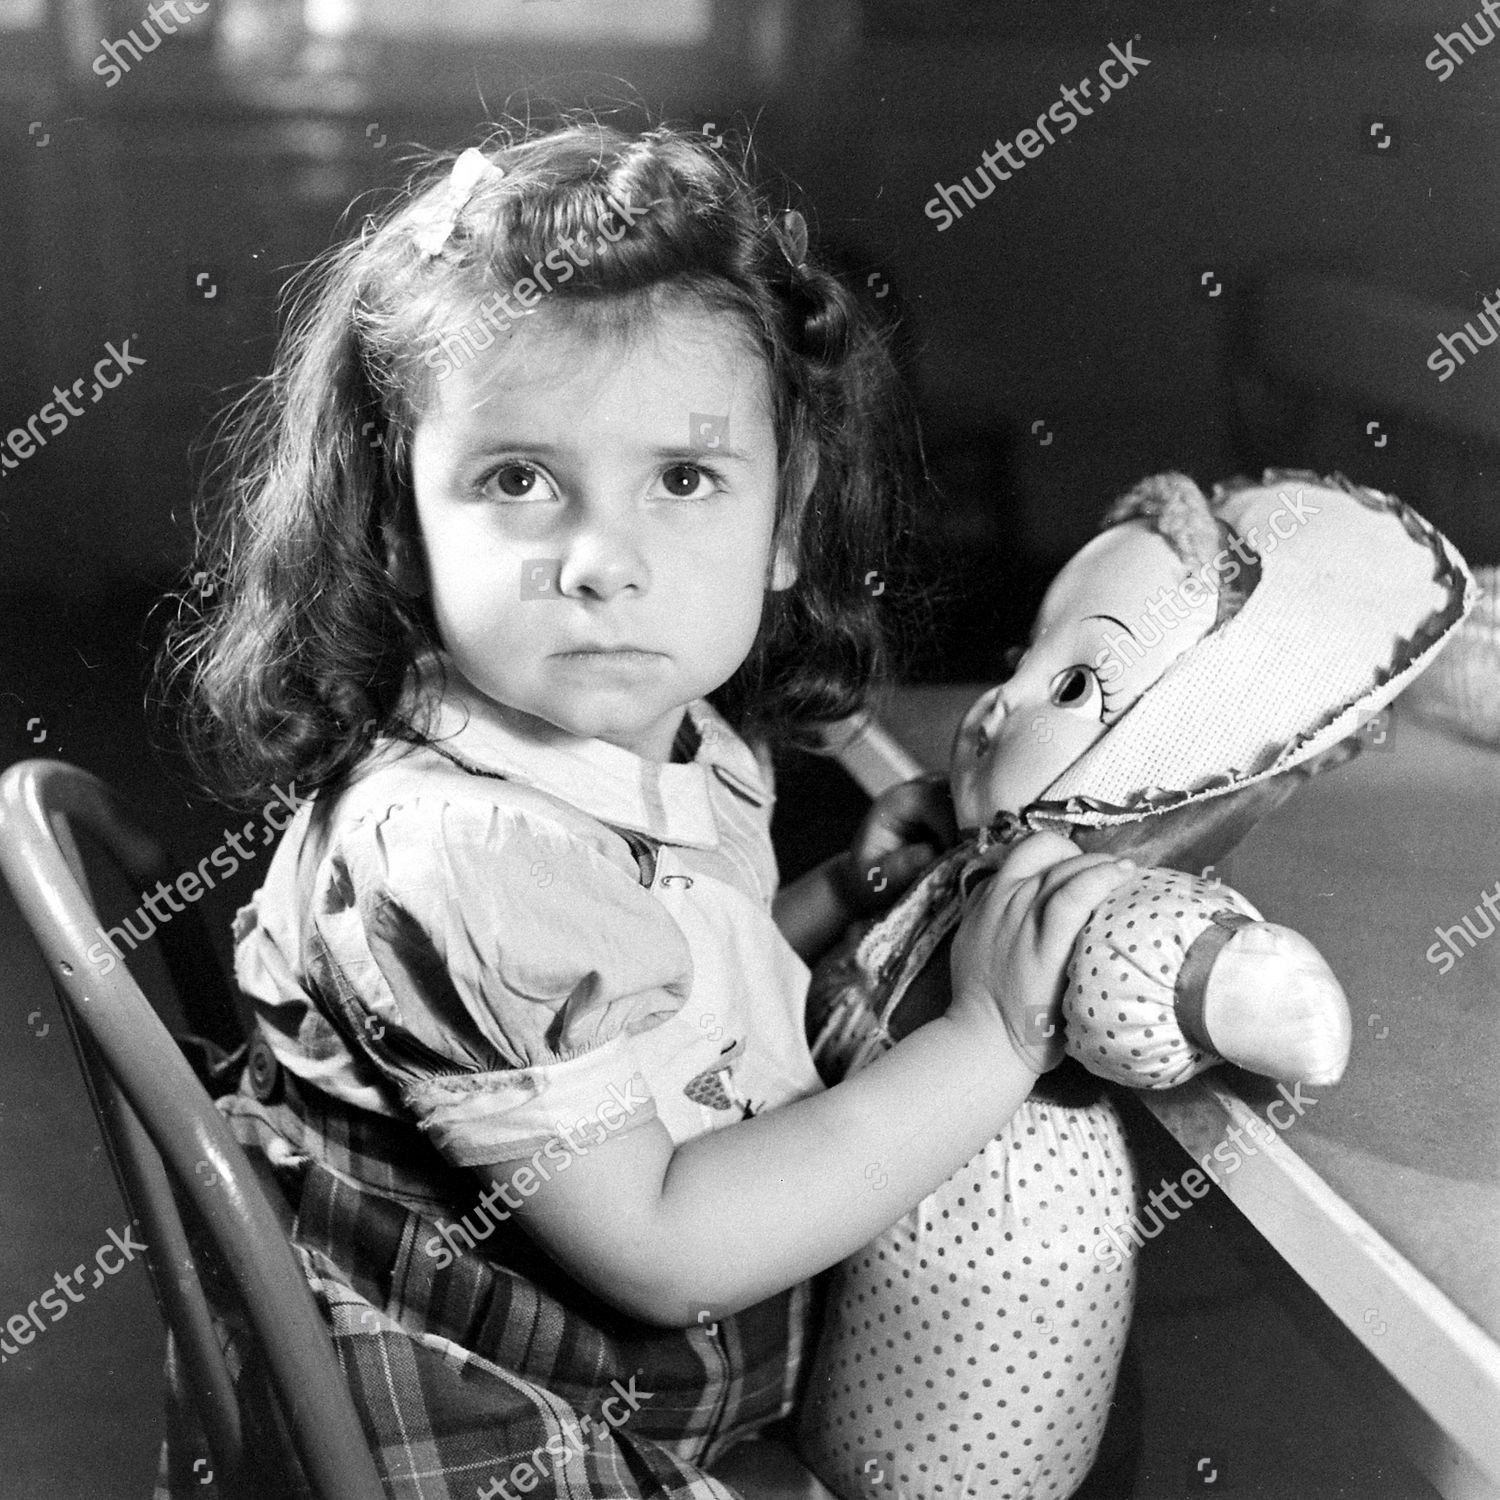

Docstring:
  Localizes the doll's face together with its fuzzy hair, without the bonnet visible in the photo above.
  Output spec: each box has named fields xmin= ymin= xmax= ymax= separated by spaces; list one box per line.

xmin=950 ymin=474 xmax=1259 ymax=828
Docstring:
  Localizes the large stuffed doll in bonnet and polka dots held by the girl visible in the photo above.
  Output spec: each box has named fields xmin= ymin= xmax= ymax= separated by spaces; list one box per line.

xmin=801 ymin=471 xmax=1476 ymax=1500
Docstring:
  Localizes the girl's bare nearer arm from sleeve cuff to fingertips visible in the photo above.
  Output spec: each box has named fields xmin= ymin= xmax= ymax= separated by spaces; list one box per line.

xmin=476 ymin=834 xmax=1130 ymax=1326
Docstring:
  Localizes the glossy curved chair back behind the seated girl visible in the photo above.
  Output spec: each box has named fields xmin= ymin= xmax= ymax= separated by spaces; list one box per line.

xmin=0 ymin=761 xmax=384 ymax=1500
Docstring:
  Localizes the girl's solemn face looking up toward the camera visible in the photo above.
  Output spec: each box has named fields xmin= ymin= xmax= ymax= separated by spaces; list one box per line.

xmin=399 ymin=300 xmax=797 ymax=761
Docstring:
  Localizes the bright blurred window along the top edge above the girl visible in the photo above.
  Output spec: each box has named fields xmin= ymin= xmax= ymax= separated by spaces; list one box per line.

xmin=57 ymin=0 xmax=804 ymax=116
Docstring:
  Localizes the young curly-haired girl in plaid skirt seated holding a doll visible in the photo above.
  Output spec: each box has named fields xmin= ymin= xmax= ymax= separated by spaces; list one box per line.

xmin=158 ymin=123 xmax=1127 ymax=1500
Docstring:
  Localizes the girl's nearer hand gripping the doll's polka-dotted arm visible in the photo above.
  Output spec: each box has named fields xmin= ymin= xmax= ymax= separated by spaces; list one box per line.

xmin=948 ymin=833 xmax=1136 ymax=1073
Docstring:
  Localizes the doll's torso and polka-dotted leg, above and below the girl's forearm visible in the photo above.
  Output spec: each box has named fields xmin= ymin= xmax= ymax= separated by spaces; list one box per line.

xmin=800 ymin=840 xmax=1136 ymax=1500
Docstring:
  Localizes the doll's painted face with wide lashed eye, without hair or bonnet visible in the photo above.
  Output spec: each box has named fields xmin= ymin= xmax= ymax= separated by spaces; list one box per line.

xmin=950 ymin=521 xmax=1218 ymax=828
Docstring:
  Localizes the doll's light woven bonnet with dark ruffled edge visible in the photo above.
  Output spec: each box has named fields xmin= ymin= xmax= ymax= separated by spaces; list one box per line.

xmin=1023 ymin=470 xmax=1479 ymax=828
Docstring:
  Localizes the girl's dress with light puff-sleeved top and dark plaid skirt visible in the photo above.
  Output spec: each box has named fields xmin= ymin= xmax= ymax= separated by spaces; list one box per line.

xmin=155 ymin=666 xmax=822 ymax=1500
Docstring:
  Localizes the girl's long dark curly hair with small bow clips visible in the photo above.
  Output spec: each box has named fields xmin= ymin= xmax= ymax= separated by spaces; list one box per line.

xmin=158 ymin=114 xmax=932 ymax=803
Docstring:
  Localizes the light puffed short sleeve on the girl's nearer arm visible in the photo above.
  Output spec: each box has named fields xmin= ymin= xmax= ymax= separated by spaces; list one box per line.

xmin=309 ymin=797 xmax=693 ymax=1167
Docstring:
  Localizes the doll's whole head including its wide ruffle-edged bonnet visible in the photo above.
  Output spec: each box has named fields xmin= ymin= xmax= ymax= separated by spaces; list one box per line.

xmin=951 ymin=470 xmax=1479 ymax=836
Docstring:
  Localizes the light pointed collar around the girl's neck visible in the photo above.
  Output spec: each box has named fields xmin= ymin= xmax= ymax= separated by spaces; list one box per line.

xmin=405 ymin=654 xmax=771 ymax=849
